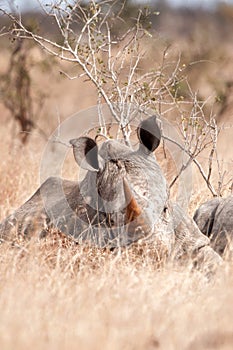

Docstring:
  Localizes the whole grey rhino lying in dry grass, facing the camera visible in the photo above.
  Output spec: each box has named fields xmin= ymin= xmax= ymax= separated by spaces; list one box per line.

xmin=0 ymin=117 xmax=221 ymax=266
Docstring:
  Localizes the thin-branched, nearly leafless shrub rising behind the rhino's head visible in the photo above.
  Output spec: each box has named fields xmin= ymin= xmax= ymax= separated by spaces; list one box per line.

xmin=2 ymin=0 xmax=229 ymax=196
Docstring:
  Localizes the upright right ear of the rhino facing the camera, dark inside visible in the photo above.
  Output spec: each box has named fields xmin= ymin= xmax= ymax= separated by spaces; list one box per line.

xmin=137 ymin=115 xmax=161 ymax=152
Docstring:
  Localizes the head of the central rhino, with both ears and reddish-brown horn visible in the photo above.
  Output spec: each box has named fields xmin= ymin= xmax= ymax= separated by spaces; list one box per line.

xmin=70 ymin=116 xmax=172 ymax=250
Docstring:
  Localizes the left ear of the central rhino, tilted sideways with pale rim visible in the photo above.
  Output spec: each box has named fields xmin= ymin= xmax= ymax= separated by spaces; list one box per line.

xmin=70 ymin=137 xmax=99 ymax=171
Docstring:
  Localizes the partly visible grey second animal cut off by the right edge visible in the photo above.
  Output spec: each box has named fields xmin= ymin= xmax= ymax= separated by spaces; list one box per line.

xmin=193 ymin=195 xmax=233 ymax=255
